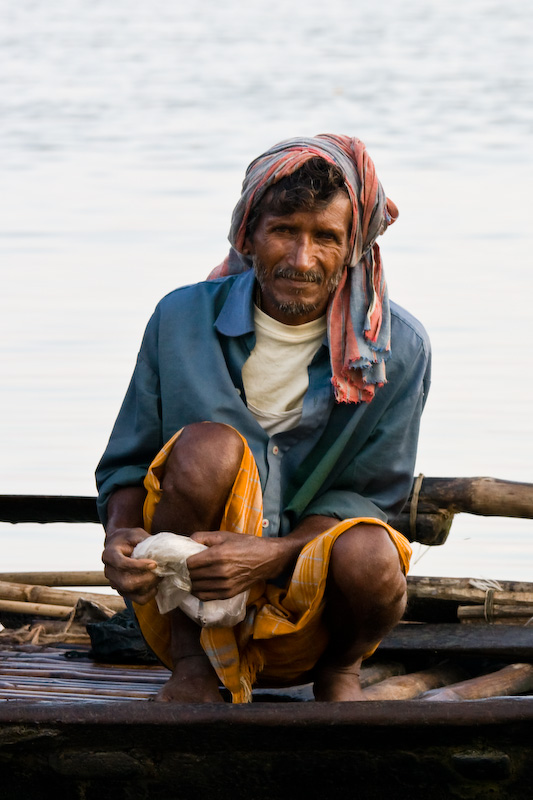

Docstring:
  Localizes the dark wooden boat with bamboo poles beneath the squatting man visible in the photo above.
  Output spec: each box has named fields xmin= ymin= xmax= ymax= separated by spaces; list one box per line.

xmin=0 ymin=479 xmax=533 ymax=800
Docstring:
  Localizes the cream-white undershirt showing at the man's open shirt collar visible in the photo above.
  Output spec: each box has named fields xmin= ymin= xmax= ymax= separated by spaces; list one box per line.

xmin=242 ymin=306 xmax=327 ymax=436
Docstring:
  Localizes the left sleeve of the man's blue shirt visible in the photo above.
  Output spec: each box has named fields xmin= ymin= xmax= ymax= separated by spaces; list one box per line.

xmin=96 ymin=312 xmax=163 ymax=524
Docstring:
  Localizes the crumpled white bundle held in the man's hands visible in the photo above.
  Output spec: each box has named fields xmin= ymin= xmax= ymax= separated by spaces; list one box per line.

xmin=132 ymin=533 xmax=248 ymax=628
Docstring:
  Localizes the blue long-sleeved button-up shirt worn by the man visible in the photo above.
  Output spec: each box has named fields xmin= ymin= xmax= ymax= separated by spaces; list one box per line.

xmin=97 ymin=271 xmax=430 ymax=536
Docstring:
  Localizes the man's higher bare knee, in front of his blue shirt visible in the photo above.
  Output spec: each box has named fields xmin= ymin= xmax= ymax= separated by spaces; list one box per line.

xmin=161 ymin=422 xmax=244 ymax=493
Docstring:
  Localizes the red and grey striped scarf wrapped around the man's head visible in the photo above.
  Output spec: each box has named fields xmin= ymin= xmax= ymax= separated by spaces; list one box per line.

xmin=209 ymin=134 xmax=398 ymax=403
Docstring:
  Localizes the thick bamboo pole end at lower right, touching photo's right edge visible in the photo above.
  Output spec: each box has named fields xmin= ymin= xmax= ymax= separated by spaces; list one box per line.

xmin=421 ymin=664 xmax=533 ymax=701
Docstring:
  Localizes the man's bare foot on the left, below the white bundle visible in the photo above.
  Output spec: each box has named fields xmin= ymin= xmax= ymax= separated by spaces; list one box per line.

xmin=154 ymin=654 xmax=224 ymax=703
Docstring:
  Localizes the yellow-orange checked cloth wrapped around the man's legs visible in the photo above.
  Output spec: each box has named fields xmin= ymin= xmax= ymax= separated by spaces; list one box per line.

xmin=134 ymin=431 xmax=411 ymax=703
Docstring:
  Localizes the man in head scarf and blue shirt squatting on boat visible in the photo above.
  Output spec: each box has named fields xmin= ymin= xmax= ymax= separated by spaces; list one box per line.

xmin=97 ymin=135 xmax=429 ymax=702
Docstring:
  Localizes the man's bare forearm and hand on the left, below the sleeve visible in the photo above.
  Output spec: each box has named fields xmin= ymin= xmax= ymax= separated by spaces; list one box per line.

xmin=102 ymin=486 xmax=159 ymax=604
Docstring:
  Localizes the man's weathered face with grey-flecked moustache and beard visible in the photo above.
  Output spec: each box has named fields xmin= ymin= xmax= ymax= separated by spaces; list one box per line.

xmin=245 ymin=191 xmax=352 ymax=325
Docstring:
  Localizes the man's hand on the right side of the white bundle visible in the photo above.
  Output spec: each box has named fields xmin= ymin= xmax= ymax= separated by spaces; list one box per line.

xmin=187 ymin=531 xmax=293 ymax=600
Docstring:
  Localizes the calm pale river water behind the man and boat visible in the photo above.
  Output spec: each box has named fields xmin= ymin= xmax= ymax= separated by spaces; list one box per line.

xmin=0 ymin=0 xmax=533 ymax=580
